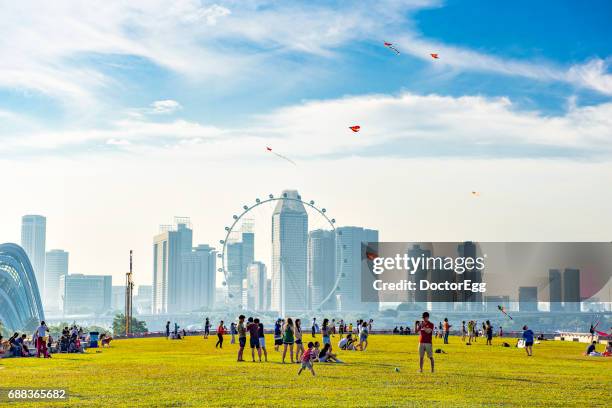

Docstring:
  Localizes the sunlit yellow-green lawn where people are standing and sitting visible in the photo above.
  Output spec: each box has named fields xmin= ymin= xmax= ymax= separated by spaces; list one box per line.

xmin=0 ymin=335 xmax=612 ymax=407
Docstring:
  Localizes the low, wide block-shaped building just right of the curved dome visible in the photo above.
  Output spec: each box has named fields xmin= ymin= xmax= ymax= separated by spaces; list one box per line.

xmin=60 ymin=274 xmax=113 ymax=314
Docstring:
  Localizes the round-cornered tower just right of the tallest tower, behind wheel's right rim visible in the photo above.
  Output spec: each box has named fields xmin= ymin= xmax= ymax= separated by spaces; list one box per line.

xmin=308 ymin=230 xmax=337 ymax=310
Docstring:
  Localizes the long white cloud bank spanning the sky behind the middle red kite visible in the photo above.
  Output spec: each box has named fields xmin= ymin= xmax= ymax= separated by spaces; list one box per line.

xmin=0 ymin=93 xmax=612 ymax=160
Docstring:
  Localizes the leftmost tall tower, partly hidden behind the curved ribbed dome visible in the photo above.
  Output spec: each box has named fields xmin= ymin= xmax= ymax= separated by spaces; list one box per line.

xmin=21 ymin=215 xmax=47 ymax=298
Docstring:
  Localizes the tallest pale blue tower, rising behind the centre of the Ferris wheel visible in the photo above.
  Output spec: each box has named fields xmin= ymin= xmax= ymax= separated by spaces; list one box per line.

xmin=272 ymin=190 xmax=308 ymax=315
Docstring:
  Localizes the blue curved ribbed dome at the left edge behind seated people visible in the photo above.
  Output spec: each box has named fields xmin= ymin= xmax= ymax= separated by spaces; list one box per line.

xmin=0 ymin=244 xmax=45 ymax=330
